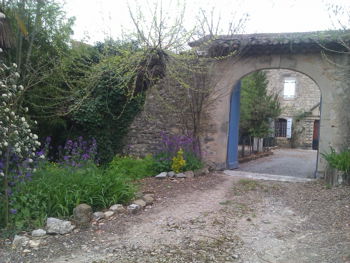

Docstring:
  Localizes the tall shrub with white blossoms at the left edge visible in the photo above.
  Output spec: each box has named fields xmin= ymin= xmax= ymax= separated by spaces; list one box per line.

xmin=0 ymin=60 xmax=44 ymax=227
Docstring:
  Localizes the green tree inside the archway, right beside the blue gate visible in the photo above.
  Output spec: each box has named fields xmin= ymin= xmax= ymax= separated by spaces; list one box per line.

xmin=240 ymin=71 xmax=281 ymax=137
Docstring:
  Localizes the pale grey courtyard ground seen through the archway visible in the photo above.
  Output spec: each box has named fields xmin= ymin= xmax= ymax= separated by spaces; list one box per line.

xmin=239 ymin=149 xmax=317 ymax=178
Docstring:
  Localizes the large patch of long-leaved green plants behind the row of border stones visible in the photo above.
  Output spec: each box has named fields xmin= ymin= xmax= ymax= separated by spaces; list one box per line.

xmin=7 ymin=163 xmax=136 ymax=233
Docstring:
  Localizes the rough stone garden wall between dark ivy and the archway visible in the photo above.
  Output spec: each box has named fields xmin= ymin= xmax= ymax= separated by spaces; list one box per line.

xmin=124 ymin=66 xmax=217 ymax=159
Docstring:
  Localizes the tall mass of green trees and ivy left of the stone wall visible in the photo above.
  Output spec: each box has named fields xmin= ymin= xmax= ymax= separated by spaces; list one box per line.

xmin=2 ymin=0 xmax=154 ymax=163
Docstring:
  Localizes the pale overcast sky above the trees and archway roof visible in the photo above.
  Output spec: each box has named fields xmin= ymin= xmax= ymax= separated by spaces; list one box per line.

xmin=63 ymin=0 xmax=350 ymax=43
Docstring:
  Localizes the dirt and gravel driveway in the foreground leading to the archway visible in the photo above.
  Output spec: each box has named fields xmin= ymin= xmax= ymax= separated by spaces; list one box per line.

xmin=0 ymin=170 xmax=350 ymax=263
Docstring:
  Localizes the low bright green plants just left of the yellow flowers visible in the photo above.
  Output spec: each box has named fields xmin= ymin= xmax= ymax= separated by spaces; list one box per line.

xmin=106 ymin=155 xmax=157 ymax=181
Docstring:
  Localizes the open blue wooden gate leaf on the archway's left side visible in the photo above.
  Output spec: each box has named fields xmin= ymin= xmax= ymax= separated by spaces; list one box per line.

xmin=227 ymin=81 xmax=241 ymax=169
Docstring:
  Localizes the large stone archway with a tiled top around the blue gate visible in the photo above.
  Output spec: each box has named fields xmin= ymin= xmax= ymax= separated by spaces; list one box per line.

xmin=192 ymin=33 xmax=350 ymax=177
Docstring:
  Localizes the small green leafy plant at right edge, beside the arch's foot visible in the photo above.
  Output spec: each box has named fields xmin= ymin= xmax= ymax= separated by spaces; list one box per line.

xmin=321 ymin=148 xmax=350 ymax=176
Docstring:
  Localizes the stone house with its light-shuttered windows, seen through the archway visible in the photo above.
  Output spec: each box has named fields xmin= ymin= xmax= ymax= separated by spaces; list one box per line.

xmin=265 ymin=69 xmax=321 ymax=149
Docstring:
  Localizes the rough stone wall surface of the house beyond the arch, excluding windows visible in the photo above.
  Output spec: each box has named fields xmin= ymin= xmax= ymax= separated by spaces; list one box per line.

xmin=265 ymin=69 xmax=321 ymax=149
